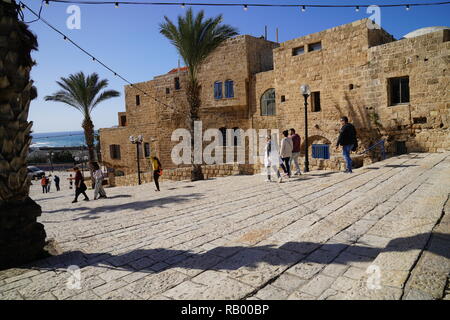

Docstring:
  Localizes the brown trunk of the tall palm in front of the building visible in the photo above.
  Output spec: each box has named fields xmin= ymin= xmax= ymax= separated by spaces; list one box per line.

xmin=186 ymin=79 xmax=205 ymax=181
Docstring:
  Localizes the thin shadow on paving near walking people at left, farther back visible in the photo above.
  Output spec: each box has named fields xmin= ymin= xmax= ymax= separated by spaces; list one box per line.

xmin=43 ymin=193 xmax=203 ymax=215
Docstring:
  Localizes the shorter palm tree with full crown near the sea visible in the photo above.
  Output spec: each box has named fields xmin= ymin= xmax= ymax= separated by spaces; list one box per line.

xmin=45 ymin=72 xmax=120 ymax=178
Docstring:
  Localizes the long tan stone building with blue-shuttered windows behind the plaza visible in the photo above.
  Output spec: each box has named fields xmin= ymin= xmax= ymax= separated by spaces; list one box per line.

xmin=100 ymin=19 xmax=450 ymax=178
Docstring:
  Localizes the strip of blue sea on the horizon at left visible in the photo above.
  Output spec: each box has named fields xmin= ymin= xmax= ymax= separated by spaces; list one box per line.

xmin=31 ymin=131 xmax=97 ymax=148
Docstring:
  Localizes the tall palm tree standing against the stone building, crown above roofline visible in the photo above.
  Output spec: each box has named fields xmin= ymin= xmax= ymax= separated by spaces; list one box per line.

xmin=159 ymin=8 xmax=238 ymax=181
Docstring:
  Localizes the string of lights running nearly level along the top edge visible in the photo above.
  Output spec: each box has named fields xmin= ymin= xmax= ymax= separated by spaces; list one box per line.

xmin=41 ymin=0 xmax=450 ymax=11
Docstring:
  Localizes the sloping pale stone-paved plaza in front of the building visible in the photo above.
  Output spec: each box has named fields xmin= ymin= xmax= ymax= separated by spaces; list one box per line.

xmin=0 ymin=152 xmax=450 ymax=300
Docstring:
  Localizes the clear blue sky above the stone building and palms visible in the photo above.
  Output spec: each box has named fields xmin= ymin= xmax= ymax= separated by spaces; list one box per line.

xmin=22 ymin=0 xmax=450 ymax=132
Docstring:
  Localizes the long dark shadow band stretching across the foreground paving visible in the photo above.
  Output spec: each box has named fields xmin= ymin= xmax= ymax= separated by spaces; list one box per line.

xmin=24 ymin=233 xmax=450 ymax=273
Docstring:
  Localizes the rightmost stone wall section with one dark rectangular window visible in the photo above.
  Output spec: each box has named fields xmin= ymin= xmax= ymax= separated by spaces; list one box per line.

xmin=364 ymin=30 xmax=450 ymax=152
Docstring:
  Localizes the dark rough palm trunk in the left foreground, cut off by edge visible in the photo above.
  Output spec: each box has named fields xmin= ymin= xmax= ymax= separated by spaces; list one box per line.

xmin=0 ymin=0 xmax=46 ymax=269
